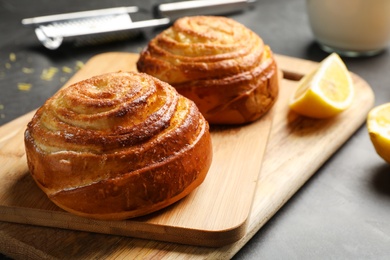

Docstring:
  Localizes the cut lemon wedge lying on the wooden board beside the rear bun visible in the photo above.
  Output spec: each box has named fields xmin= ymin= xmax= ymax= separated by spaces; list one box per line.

xmin=289 ymin=53 xmax=354 ymax=118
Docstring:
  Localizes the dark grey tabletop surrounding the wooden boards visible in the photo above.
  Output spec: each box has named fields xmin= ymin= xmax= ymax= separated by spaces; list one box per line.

xmin=0 ymin=0 xmax=390 ymax=259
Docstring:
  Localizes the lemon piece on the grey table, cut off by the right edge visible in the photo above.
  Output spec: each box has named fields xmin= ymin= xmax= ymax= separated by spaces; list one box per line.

xmin=367 ymin=103 xmax=390 ymax=163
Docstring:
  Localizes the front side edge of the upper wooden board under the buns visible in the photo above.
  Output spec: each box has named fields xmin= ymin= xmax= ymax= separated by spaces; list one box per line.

xmin=0 ymin=206 xmax=249 ymax=247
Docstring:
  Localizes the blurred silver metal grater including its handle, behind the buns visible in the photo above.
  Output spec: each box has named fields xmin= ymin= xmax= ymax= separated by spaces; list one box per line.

xmin=22 ymin=0 xmax=255 ymax=50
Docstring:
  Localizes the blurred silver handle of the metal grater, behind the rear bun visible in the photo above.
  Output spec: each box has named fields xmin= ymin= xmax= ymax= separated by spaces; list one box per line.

xmin=156 ymin=0 xmax=256 ymax=20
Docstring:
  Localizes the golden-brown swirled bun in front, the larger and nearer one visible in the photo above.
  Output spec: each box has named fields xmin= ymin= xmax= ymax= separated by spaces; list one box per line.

xmin=25 ymin=72 xmax=212 ymax=220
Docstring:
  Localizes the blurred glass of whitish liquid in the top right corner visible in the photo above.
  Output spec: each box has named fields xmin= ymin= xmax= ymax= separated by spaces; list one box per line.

xmin=306 ymin=0 xmax=390 ymax=57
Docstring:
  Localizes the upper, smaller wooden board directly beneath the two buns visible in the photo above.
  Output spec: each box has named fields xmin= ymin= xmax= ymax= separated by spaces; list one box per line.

xmin=0 ymin=53 xmax=272 ymax=246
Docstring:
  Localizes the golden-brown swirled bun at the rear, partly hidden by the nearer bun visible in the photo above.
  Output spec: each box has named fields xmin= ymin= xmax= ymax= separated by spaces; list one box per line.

xmin=137 ymin=16 xmax=278 ymax=124
